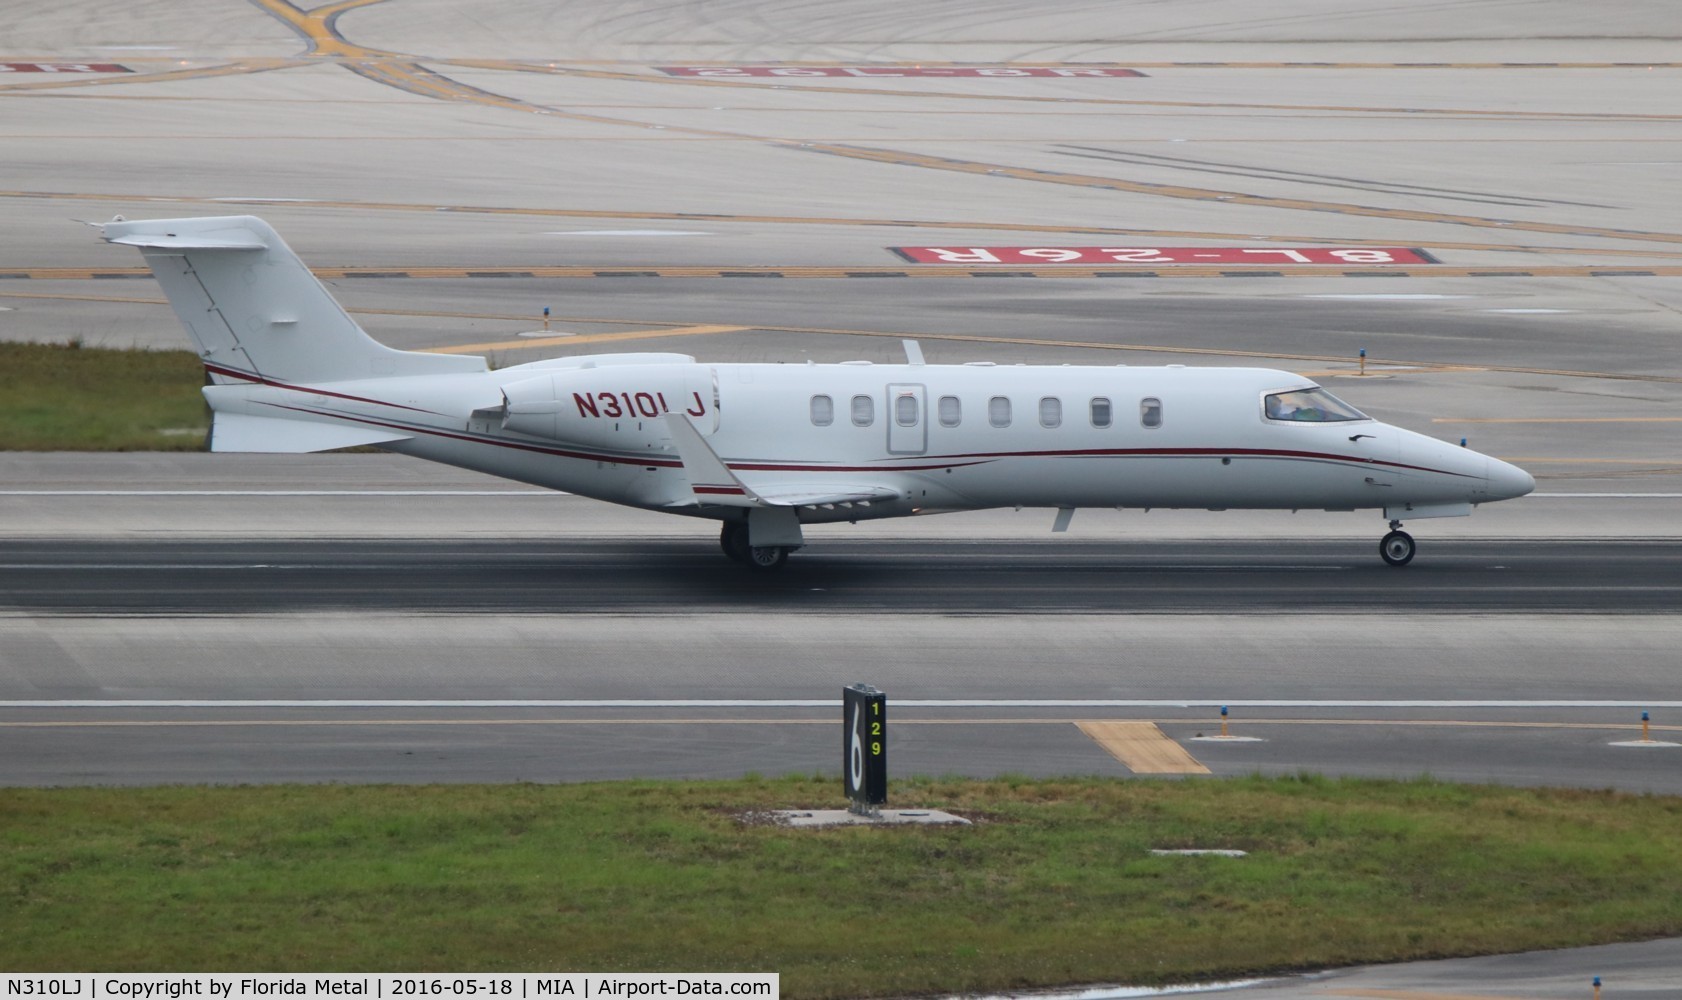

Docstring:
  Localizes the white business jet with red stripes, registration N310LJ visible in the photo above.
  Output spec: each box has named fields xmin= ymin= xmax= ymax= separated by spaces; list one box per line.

xmin=99 ymin=215 xmax=1536 ymax=568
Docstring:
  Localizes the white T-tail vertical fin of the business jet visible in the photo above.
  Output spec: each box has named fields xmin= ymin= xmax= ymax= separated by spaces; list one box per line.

xmin=99 ymin=215 xmax=484 ymax=383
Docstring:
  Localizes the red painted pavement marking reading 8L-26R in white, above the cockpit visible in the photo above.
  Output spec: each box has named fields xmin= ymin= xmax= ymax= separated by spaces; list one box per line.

xmin=888 ymin=247 xmax=1436 ymax=264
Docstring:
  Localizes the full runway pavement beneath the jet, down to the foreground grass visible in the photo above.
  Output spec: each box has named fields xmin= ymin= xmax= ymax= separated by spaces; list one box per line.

xmin=0 ymin=473 xmax=1682 ymax=792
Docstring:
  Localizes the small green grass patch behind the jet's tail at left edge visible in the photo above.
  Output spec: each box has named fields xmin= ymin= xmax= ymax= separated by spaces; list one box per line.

xmin=0 ymin=343 xmax=210 ymax=452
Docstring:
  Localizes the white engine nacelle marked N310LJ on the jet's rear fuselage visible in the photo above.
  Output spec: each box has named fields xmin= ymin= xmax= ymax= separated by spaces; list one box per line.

xmin=501 ymin=365 xmax=718 ymax=450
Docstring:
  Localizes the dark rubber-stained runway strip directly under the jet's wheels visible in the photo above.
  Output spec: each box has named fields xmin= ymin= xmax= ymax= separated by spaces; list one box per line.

xmin=0 ymin=534 xmax=1682 ymax=618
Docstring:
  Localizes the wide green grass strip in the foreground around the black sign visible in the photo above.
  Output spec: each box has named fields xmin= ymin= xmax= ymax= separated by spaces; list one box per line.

xmin=0 ymin=776 xmax=1682 ymax=997
